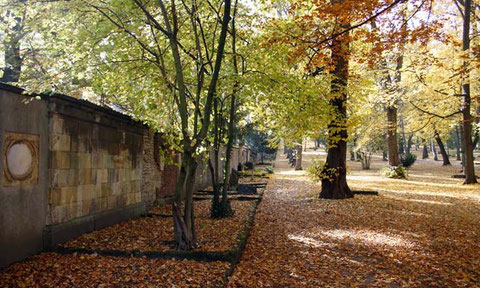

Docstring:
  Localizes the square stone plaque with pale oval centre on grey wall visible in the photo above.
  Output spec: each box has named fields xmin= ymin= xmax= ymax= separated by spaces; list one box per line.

xmin=2 ymin=132 xmax=40 ymax=186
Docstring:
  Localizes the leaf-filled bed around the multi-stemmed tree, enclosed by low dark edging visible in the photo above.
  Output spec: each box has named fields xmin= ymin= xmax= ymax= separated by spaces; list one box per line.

xmin=63 ymin=200 xmax=254 ymax=252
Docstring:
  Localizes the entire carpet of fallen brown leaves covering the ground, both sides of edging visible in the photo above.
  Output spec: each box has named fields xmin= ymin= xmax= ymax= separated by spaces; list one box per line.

xmin=0 ymin=150 xmax=480 ymax=288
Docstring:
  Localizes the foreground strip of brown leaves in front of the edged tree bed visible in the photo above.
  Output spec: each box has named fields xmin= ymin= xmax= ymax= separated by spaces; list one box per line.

xmin=0 ymin=253 xmax=229 ymax=288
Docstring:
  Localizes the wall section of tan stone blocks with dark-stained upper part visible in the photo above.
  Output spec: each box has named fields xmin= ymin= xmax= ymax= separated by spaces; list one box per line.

xmin=44 ymin=95 xmax=148 ymax=247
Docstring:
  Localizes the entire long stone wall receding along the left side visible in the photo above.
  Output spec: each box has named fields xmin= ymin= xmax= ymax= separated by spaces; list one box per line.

xmin=0 ymin=83 xmax=243 ymax=267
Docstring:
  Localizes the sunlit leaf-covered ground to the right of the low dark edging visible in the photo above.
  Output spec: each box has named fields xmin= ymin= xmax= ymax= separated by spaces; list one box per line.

xmin=229 ymin=151 xmax=480 ymax=287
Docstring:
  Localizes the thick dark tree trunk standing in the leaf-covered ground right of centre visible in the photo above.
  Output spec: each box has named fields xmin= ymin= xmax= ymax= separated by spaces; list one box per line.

xmin=320 ymin=0 xmax=353 ymax=199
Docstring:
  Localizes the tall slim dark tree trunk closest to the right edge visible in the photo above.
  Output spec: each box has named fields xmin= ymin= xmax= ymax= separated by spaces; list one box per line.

xmin=462 ymin=0 xmax=477 ymax=184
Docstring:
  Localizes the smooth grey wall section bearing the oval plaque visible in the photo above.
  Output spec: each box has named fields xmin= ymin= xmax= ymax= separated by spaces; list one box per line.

xmin=0 ymin=83 xmax=48 ymax=267
